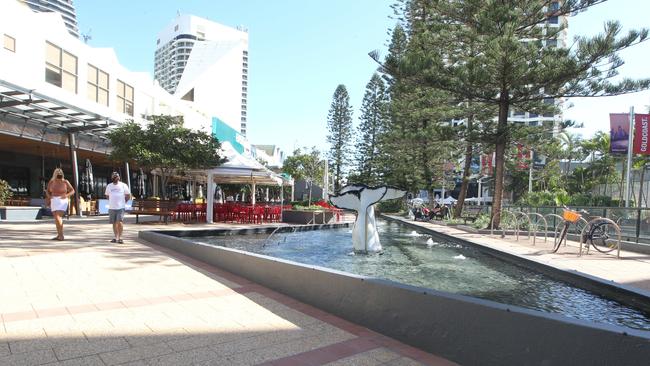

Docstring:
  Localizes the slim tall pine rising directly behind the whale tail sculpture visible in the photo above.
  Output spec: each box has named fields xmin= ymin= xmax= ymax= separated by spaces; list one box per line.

xmin=355 ymin=73 xmax=388 ymax=185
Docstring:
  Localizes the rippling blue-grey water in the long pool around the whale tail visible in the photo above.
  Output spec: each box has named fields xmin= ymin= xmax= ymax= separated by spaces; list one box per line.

xmin=196 ymin=221 xmax=650 ymax=331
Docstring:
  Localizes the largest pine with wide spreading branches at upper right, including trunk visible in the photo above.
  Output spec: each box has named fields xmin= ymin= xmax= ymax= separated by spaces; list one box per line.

xmin=390 ymin=0 xmax=650 ymax=226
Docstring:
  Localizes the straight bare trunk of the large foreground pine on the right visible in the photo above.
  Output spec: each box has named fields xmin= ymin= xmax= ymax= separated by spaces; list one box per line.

xmin=492 ymin=97 xmax=508 ymax=228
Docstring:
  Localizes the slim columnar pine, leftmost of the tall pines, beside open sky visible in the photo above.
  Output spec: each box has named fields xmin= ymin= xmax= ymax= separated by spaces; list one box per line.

xmin=327 ymin=84 xmax=352 ymax=191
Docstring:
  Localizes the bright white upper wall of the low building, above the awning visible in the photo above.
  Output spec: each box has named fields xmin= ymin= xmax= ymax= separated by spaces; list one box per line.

xmin=0 ymin=1 xmax=211 ymax=132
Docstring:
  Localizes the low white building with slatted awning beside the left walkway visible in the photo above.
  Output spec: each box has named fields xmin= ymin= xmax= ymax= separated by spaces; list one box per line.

xmin=0 ymin=0 xmax=213 ymax=203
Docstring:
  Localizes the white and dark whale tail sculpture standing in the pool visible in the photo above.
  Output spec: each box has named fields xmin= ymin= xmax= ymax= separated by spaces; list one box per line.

xmin=330 ymin=184 xmax=406 ymax=253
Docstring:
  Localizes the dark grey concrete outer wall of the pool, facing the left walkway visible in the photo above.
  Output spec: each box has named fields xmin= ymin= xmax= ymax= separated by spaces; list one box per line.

xmin=139 ymin=227 xmax=650 ymax=365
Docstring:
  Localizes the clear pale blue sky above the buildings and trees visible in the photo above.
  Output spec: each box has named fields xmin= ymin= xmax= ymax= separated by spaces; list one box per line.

xmin=75 ymin=0 xmax=650 ymax=154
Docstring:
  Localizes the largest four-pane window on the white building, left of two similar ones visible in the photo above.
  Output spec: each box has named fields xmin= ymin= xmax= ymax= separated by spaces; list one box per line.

xmin=45 ymin=42 xmax=77 ymax=94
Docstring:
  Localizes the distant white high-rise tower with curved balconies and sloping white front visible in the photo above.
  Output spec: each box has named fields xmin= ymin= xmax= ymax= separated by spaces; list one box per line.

xmin=154 ymin=15 xmax=248 ymax=136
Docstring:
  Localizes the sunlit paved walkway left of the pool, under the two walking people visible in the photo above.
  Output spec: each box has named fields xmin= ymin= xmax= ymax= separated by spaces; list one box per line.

xmin=0 ymin=218 xmax=453 ymax=366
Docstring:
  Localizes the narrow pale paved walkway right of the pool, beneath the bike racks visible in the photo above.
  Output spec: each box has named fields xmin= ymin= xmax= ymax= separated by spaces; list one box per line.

xmin=391 ymin=216 xmax=650 ymax=292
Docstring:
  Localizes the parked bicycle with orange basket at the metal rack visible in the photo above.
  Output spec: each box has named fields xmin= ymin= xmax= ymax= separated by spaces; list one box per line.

xmin=552 ymin=206 xmax=620 ymax=256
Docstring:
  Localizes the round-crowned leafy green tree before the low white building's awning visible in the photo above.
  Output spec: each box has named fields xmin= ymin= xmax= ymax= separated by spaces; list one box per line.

xmin=108 ymin=115 xmax=224 ymax=198
